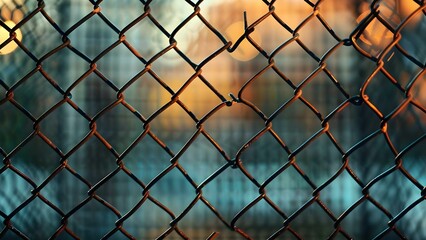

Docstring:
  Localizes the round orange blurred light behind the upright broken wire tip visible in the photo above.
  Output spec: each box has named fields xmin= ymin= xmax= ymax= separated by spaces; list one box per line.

xmin=225 ymin=21 xmax=261 ymax=61
